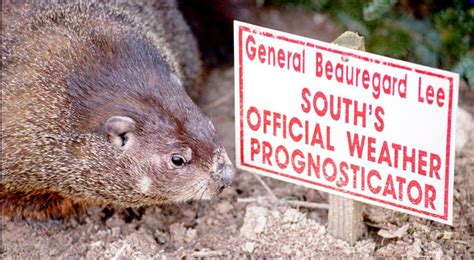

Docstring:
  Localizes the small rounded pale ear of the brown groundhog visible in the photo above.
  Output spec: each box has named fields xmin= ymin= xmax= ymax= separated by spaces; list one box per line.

xmin=105 ymin=116 xmax=135 ymax=150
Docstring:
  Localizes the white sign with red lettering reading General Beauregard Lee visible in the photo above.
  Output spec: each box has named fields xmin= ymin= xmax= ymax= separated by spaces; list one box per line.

xmin=234 ymin=21 xmax=459 ymax=224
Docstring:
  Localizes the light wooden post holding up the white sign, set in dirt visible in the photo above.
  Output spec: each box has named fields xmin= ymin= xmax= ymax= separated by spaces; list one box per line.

xmin=328 ymin=32 xmax=365 ymax=246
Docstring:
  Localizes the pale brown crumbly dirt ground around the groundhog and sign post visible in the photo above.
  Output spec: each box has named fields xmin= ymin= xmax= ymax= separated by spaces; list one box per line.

xmin=0 ymin=7 xmax=474 ymax=259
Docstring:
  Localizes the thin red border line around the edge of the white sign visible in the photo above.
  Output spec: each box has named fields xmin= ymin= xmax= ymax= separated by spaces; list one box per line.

xmin=238 ymin=25 xmax=454 ymax=221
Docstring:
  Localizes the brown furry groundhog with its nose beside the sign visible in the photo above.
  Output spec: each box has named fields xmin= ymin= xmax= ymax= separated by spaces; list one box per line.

xmin=0 ymin=0 xmax=234 ymax=219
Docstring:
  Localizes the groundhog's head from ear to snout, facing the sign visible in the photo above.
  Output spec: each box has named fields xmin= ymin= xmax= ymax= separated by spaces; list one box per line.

xmin=104 ymin=73 xmax=234 ymax=204
